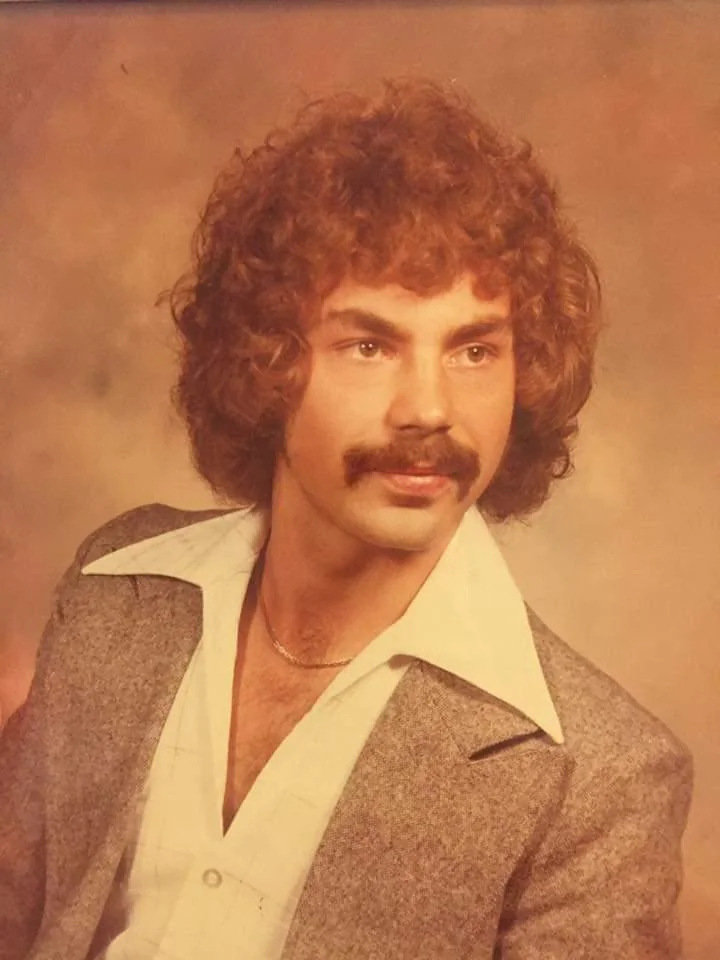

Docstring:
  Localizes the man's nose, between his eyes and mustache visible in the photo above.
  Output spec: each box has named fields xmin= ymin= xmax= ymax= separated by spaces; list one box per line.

xmin=388 ymin=359 xmax=451 ymax=433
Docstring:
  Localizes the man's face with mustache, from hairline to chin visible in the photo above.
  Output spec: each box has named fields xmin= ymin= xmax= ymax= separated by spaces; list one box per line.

xmin=273 ymin=276 xmax=515 ymax=551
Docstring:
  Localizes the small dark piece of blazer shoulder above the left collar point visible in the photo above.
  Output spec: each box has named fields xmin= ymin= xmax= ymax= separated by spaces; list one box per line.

xmin=79 ymin=503 xmax=231 ymax=564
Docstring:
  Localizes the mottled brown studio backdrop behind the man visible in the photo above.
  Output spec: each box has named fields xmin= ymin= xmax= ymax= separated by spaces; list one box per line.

xmin=0 ymin=2 xmax=720 ymax=960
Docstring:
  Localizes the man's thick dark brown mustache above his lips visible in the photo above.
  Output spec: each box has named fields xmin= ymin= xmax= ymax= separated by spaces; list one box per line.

xmin=343 ymin=434 xmax=480 ymax=500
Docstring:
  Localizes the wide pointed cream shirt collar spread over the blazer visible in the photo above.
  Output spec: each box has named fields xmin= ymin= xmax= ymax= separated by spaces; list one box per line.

xmin=83 ymin=508 xmax=564 ymax=743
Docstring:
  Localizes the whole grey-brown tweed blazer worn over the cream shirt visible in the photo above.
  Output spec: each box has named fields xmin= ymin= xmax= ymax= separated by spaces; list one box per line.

xmin=0 ymin=506 xmax=692 ymax=960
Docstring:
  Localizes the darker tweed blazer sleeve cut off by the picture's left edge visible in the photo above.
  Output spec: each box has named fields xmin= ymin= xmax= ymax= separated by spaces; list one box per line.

xmin=0 ymin=537 xmax=92 ymax=960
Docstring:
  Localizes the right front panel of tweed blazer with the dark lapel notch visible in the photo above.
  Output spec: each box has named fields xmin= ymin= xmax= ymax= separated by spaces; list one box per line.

xmin=283 ymin=662 xmax=568 ymax=960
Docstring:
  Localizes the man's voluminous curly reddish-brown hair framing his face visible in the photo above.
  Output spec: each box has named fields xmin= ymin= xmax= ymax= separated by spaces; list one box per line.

xmin=169 ymin=80 xmax=600 ymax=520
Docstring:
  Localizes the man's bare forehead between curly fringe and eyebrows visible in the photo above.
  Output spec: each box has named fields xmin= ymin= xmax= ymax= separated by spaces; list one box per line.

xmin=320 ymin=276 xmax=510 ymax=328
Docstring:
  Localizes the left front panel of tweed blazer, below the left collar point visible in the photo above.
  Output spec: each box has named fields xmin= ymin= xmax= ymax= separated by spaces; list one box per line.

xmin=44 ymin=576 xmax=202 ymax=956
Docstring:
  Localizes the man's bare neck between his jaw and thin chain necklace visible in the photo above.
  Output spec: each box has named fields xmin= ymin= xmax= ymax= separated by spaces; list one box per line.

xmin=260 ymin=498 xmax=449 ymax=661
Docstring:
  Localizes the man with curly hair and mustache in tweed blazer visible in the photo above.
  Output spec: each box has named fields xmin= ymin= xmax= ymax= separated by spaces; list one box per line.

xmin=0 ymin=82 xmax=691 ymax=960
